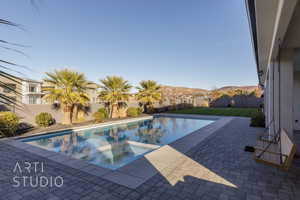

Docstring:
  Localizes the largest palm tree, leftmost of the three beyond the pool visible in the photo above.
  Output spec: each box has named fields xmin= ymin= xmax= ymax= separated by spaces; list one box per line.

xmin=43 ymin=69 xmax=91 ymax=124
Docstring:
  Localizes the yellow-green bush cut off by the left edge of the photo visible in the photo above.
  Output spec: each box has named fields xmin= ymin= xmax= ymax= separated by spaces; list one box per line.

xmin=0 ymin=111 xmax=20 ymax=137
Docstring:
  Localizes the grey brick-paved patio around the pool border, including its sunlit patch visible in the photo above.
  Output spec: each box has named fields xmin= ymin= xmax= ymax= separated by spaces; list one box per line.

xmin=0 ymin=118 xmax=300 ymax=200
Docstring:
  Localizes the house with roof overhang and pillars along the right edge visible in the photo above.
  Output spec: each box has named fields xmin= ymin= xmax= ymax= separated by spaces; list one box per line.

xmin=246 ymin=0 xmax=300 ymax=137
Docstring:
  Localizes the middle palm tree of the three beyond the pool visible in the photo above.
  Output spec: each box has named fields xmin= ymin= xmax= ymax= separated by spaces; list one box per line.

xmin=99 ymin=76 xmax=132 ymax=118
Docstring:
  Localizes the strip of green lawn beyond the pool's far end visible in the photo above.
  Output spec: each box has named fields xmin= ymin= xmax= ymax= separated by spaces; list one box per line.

xmin=169 ymin=107 xmax=259 ymax=117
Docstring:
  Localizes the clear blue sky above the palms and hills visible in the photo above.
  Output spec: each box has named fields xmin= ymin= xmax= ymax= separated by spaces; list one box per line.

xmin=0 ymin=0 xmax=257 ymax=89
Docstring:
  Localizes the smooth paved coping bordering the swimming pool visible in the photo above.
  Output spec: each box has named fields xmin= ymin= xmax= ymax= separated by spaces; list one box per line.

xmin=0 ymin=113 xmax=234 ymax=189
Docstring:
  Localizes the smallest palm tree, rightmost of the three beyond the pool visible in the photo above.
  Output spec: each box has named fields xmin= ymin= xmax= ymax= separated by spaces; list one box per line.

xmin=136 ymin=80 xmax=162 ymax=112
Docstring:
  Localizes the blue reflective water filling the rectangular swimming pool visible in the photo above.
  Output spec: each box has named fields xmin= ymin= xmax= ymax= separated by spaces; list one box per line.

xmin=22 ymin=117 xmax=213 ymax=169
